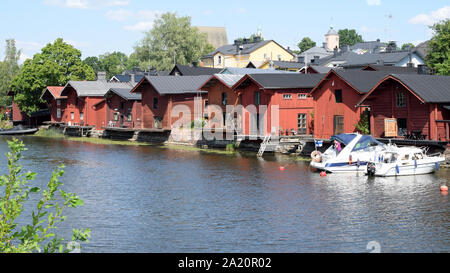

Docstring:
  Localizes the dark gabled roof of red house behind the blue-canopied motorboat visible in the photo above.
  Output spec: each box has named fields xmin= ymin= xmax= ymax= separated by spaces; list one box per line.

xmin=311 ymin=69 xmax=388 ymax=94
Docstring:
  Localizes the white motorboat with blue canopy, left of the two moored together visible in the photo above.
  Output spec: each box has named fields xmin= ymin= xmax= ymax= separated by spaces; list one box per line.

xmin=311 ymin=133 xmax=388 ymax=173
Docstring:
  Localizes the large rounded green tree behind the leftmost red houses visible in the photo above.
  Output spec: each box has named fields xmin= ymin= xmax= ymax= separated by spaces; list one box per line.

xmin=11 ymin=38 xmax=95 ymax=113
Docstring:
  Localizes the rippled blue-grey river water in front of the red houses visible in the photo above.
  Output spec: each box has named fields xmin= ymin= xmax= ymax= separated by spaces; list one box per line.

xmin=0 ymin=137 xmax=450 ymax=253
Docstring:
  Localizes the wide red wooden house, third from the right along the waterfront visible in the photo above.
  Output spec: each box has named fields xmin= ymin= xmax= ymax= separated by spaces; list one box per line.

xmin=233 ymin=73 xmax=324 ymax=136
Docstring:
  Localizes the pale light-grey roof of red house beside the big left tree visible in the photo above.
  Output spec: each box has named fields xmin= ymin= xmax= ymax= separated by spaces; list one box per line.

xmin=61 ymin=81 xmax=133 ymax=97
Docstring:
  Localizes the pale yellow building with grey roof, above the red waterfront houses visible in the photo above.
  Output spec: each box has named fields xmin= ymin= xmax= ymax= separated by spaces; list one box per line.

xmin=201 ymin=40 xmax=295 ymax=68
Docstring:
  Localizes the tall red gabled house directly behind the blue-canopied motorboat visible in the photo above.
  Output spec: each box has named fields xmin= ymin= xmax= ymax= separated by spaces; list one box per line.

xmin=311 ymin=70 xmax=387 ymax=139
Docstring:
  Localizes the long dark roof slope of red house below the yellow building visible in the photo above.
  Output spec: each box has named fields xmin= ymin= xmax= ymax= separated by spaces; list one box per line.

xmin=241 ymin=73 xmax=325 ymax=89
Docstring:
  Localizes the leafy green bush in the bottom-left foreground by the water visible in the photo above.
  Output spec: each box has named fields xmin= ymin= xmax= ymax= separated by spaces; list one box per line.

xmin=0 ymin=139 xmax=90 ymax=253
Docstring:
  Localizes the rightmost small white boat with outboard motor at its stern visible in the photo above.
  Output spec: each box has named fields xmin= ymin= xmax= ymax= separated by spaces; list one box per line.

xmin=366 ymin=147 xmax=445 ymax=176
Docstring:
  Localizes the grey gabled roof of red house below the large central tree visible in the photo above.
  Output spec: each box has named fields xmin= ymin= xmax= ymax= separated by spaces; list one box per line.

xmin=131 ymin=75 xmax=211 ymax=95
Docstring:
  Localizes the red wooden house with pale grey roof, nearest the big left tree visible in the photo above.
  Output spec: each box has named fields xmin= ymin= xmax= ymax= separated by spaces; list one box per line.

xmin=61 ymin=71 xmax=133 ymax=130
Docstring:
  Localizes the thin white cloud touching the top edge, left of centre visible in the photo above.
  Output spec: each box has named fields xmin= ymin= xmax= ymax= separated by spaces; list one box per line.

xmin=44 ymin=0 xmax=130 ymax=9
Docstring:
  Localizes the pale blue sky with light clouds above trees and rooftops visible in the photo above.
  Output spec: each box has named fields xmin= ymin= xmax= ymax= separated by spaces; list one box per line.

xmin=0 ymin=0 xmax=450 ymax=59
